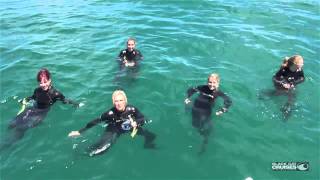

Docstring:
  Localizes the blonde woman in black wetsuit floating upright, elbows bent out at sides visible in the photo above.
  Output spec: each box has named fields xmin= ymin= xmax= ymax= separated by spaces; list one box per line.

xmin=185 ymin=74 xmax=232 ymax=153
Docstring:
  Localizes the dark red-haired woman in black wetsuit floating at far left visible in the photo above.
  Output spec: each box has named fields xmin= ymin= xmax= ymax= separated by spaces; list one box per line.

xmin=1 ymin=69 xmax=78 ymax=147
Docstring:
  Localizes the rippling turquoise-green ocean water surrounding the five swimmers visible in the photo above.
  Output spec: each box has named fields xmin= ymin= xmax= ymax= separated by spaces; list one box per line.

xmin=0 ymin=0 xmax=320 ymax=180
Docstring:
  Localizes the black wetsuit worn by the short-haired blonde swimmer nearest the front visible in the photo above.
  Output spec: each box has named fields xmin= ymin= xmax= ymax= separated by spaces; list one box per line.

xmin=79 ymin=105 xmax=155 ymax=156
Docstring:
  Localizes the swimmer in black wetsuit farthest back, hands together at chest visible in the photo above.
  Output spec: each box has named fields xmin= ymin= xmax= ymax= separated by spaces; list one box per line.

xmin=118 ymin=38 xmax=143 ymax=68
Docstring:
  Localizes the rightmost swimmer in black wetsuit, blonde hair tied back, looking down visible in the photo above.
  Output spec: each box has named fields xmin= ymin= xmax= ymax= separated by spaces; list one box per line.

xmin=266 ymin=55 xmax=305 ymax=120
